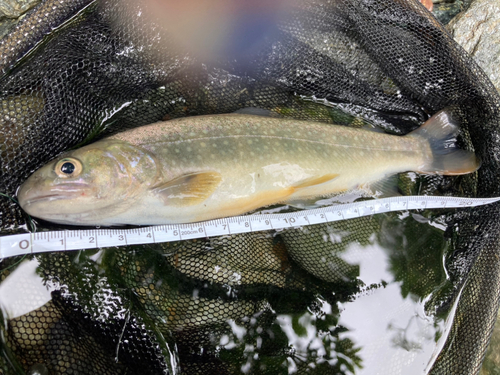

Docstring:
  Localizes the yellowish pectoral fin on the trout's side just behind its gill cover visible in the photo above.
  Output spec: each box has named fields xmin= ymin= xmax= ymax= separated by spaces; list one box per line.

xmin=151 ymin=171 xmax=222 ymax=206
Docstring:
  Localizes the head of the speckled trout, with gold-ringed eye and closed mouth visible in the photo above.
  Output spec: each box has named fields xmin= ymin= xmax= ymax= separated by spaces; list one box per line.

xmin=17 ymin=139 xmax=159 ymax=225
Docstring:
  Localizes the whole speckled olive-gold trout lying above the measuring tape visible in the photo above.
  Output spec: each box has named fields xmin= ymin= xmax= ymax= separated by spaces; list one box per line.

xmin=17 ymin=110 xmax=480 ymax=226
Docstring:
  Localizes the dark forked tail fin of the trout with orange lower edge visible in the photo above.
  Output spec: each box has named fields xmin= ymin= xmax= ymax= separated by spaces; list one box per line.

xmin=408 ymin=110 xmax=481 ymax=175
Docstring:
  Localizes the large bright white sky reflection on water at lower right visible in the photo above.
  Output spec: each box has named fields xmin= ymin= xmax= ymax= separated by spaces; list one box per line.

xmin=339 ymin=264 xmax=443 ymax=374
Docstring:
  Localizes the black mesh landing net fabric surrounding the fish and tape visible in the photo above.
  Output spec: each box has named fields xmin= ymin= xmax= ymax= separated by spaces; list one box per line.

xmin=0 ymin=0 xmax=500 ymax=374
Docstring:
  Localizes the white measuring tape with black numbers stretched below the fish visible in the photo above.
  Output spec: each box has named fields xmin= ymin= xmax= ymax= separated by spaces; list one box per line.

xmin=0 ymin=196 xmax=500 ymax=259
